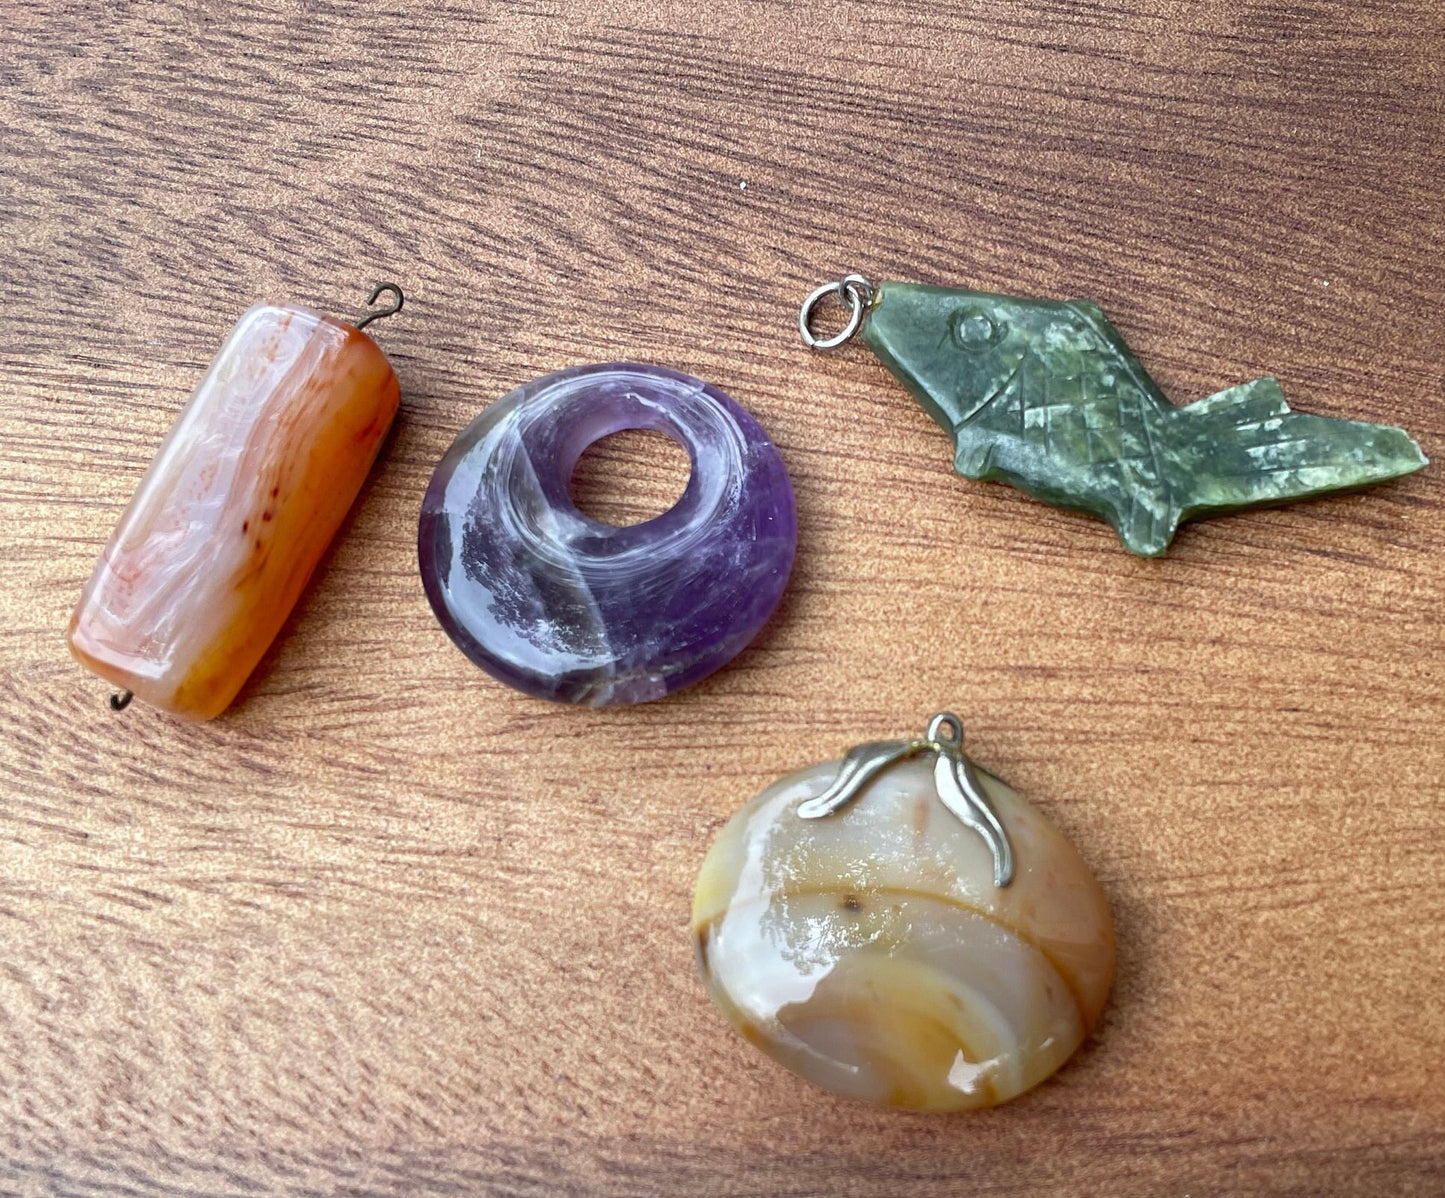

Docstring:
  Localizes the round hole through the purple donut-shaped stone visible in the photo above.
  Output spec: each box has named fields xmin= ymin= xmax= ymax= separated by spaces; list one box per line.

xmin=571 ymin=428 xmax=692 ymax=527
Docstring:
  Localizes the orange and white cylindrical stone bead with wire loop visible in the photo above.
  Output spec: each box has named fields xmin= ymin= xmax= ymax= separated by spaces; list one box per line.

xmin=66 ymin=285 xmax=402 ymax=720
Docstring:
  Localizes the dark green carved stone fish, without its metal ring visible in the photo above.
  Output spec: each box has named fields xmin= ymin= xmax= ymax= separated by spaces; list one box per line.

xmin=840 ymin=283 xmax=1426 ymax=556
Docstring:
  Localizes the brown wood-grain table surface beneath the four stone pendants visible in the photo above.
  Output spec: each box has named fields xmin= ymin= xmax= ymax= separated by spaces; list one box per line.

xmin=0 ymin=0 xmax=1445 ymax=1198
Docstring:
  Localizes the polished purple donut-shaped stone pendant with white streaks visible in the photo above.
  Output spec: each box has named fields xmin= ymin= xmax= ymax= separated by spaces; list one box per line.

xmin=418 ymin=363 xmax=798 ymax=707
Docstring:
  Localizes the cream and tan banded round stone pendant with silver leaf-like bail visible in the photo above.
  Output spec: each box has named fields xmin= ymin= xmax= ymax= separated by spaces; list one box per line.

xmin=692 ymin=715 xmax=1114 ymax=1111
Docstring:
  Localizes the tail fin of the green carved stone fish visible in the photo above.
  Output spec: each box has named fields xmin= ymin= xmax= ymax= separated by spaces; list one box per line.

xmin=1179 ymin=377 xmax=1428 ymax=519
